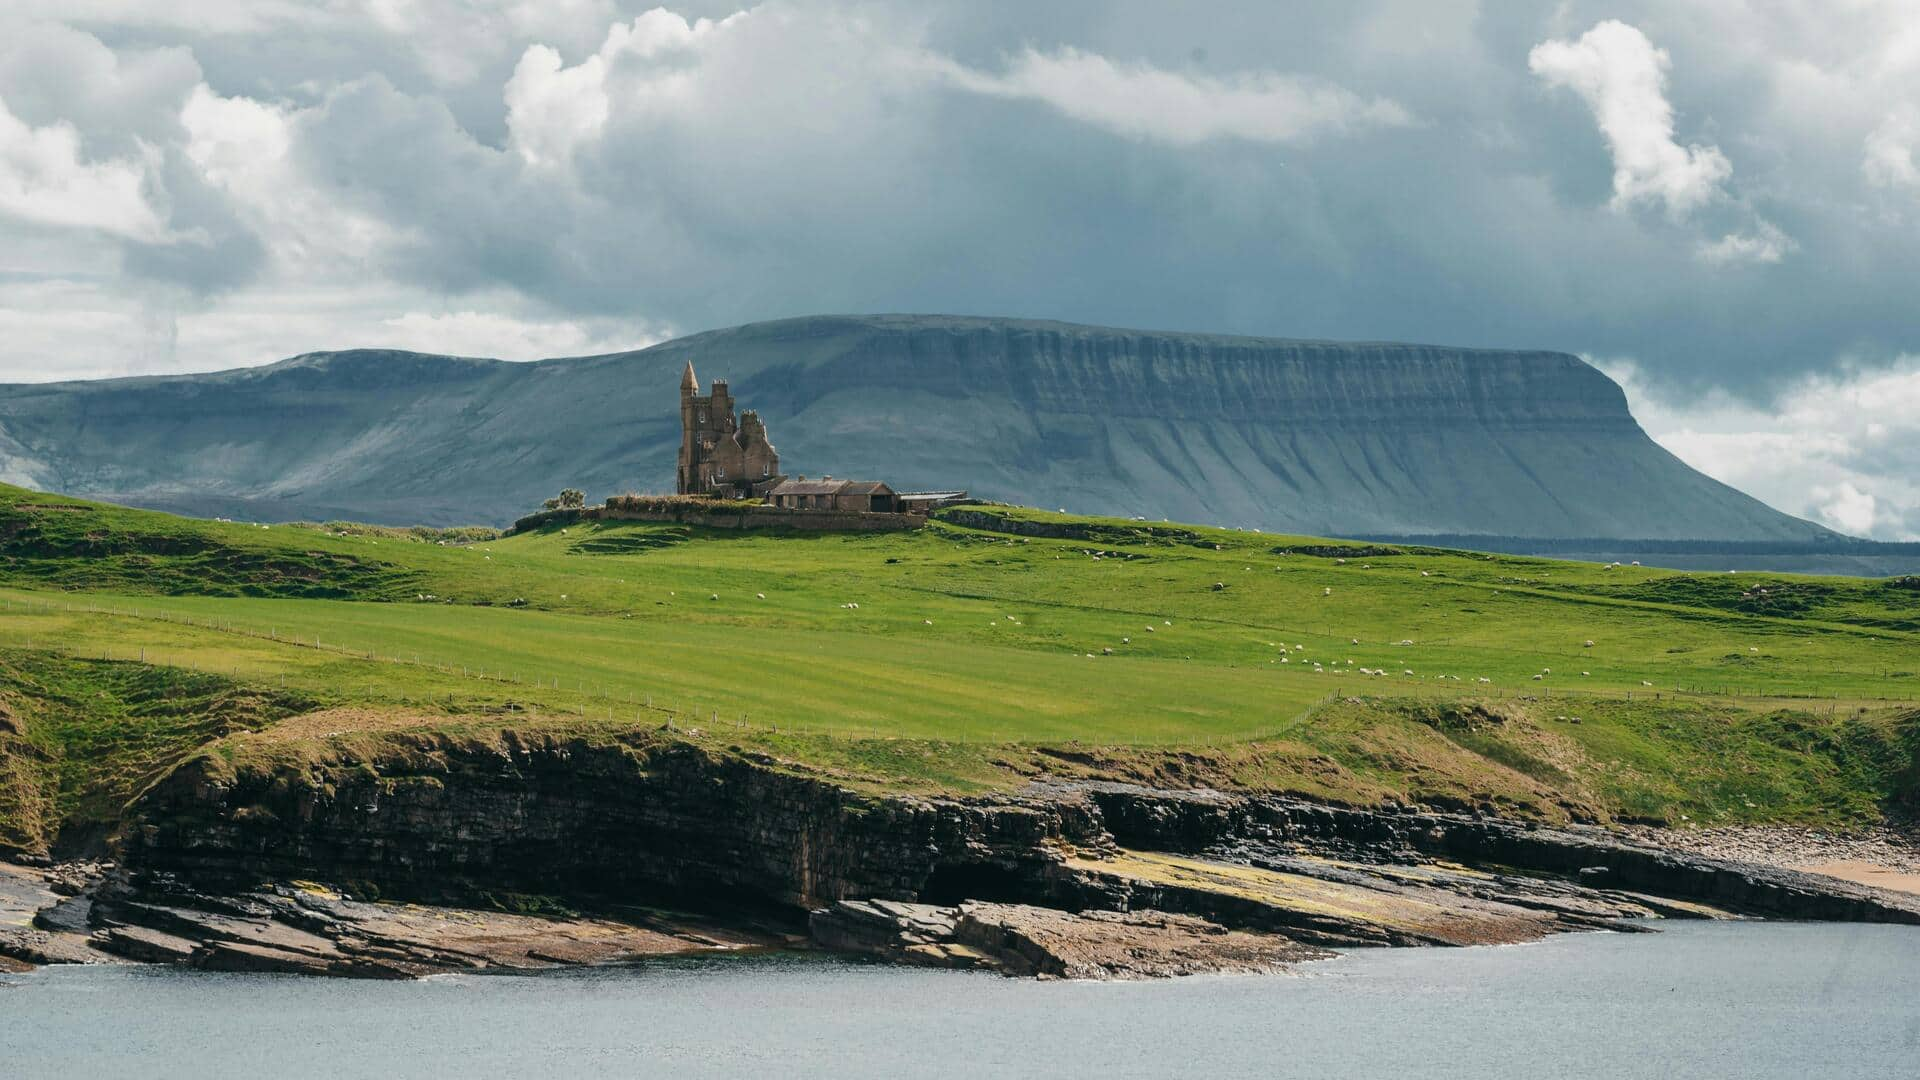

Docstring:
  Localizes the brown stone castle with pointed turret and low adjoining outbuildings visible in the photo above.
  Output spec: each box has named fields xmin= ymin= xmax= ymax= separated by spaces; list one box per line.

xmin=676 ymin=359 xmax=966 ymax=515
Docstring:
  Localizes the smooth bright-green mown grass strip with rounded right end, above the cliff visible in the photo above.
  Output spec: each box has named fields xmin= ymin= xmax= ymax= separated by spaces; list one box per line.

xmin=4 ymin=592 xmax=1331 ymax=744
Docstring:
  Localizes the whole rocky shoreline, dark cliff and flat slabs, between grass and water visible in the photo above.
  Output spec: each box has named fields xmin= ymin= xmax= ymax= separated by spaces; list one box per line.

xmin=0 ymin=734 xmax=1920 ymax=978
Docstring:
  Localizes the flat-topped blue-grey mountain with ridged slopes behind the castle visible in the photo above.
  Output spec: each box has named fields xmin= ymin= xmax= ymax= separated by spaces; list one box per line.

xmin=0 ymin=315 xmax=1832 ymax=540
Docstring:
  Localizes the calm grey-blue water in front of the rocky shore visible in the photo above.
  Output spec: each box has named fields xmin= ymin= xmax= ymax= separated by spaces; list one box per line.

xmin=0 ymin=922 xmax=1920 ymax=1080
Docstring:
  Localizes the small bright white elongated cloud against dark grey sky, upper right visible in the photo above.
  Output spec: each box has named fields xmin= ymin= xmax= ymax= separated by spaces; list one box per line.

xmin=1526 ymin=19 xmax=1734 ymax=217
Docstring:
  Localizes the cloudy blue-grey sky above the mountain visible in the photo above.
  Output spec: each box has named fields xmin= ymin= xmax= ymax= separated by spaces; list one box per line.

xmin=0 ymin=0 xmax=1920 ymax=538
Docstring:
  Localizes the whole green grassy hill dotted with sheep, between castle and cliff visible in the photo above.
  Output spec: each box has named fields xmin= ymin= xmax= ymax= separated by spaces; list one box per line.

xmin=0 ymin=488 xmax=1920 ymax=847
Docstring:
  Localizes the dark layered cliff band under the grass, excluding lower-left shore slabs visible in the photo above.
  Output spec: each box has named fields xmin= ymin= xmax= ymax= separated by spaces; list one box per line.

xmin=123 ymin=730 xmax=1920 ymax=945
